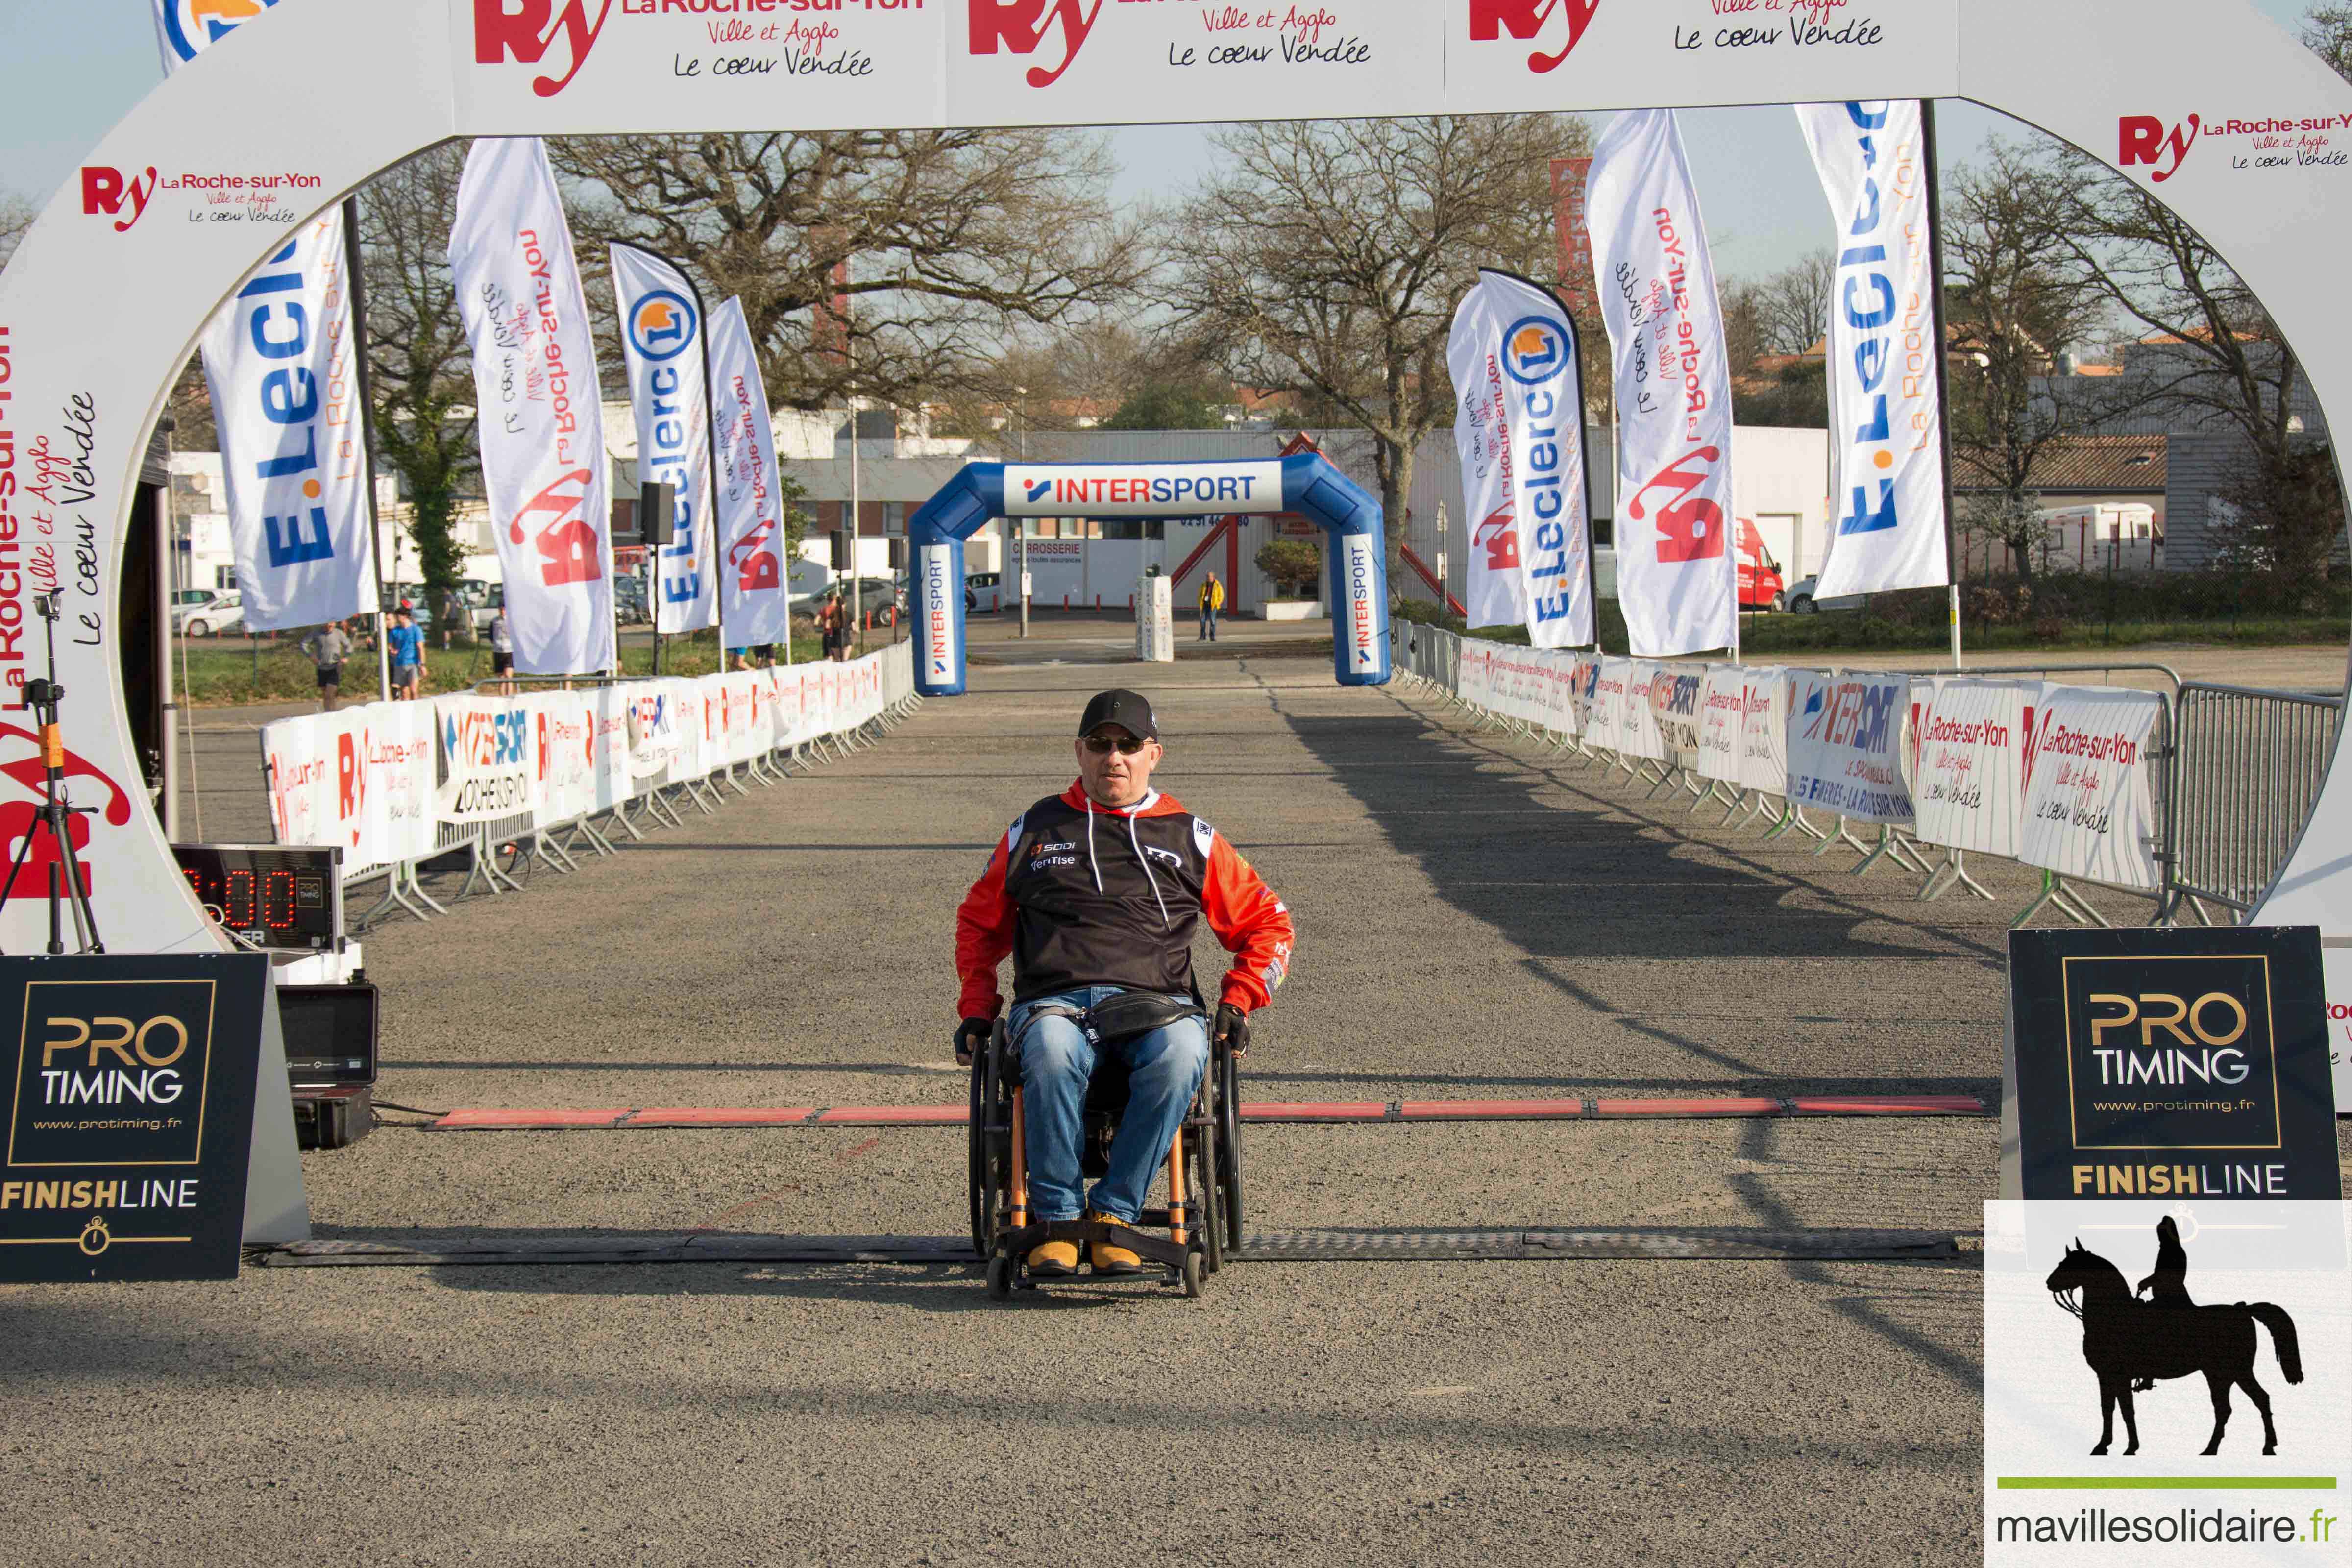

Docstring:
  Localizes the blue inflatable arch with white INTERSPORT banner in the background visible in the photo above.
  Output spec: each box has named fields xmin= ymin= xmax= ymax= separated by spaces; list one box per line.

xmin=906 ymin=451 xmax=1388 ymax=696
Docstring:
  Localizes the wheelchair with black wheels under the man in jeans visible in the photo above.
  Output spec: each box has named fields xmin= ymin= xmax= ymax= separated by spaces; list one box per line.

xmin=969 ymin=1018 xmax=1242 ymax=1300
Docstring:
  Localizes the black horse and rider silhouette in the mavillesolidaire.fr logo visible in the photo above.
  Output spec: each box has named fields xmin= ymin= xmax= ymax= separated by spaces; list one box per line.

xmin=2041 ymin=1215 xmax=2303 ymax=1455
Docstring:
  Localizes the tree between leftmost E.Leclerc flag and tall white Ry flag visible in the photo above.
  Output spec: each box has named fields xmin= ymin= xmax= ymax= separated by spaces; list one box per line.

xmin=360 ymin=144 xmax=482 ymax=625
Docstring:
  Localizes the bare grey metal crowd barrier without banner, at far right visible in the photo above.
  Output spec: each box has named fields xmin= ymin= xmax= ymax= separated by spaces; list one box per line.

xmin=2173 ymin=682 xmax=2345 ymax=924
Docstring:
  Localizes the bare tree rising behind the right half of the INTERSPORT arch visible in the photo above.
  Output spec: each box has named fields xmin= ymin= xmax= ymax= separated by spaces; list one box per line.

xmin=1169 ymin=115 xmax=1588 ymax=581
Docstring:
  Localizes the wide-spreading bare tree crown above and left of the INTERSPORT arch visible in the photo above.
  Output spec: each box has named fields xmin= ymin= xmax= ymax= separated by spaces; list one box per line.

xmin=548 ymin=129 xmax=1143 ymax=409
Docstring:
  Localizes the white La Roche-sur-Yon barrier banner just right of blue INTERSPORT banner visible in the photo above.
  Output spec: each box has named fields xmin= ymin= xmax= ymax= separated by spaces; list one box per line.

xmin=1912 ymin=680 xmax=2041 ymax=860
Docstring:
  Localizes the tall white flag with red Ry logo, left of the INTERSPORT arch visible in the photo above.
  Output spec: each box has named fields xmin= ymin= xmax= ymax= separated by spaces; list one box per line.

xmin=449 ymin=136 xmax=614 ymax=675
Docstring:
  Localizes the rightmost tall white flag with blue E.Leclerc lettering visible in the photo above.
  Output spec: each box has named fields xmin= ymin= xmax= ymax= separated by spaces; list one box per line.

xmin=1797 ymin=98 xmax=1952 ymax=599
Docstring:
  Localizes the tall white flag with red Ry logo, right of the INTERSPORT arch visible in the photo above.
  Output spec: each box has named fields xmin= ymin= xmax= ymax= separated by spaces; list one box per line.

xmin=1585 ymin=108 xmax=1738 ymax=658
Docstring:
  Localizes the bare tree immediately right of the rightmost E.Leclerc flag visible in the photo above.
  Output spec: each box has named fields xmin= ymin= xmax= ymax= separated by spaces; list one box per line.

xmin=1943 ymin=139 xmax=2110 ymax=576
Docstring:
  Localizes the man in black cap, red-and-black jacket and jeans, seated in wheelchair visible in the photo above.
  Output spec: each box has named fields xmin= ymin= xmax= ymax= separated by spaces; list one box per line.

xmin=955 ymin=691 xmax=1294 ymax=1276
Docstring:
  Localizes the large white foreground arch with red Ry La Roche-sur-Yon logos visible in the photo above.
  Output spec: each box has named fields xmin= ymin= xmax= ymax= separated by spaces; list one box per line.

xmin=0 ymin=0 xmax=2352 ymax=999
